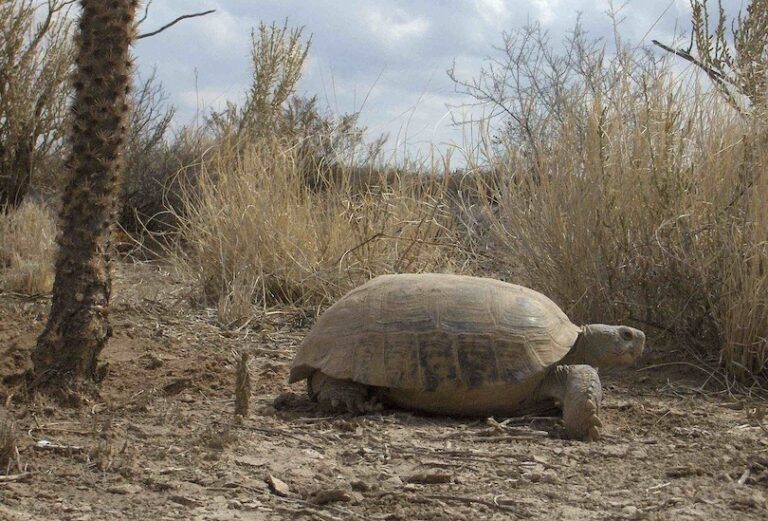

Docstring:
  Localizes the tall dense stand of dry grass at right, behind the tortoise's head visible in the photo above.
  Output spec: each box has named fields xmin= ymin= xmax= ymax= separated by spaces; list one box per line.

xmin=450 ymin=26 xmax=768 ymax=381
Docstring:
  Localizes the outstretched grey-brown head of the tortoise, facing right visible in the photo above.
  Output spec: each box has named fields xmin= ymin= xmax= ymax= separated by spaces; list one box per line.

xmin=568 ymin=324 xmax=645 ymax=369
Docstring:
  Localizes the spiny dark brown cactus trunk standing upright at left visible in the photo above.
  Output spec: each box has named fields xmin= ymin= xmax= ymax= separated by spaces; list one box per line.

xmin=32 ymin=0 xmax=138 ymax=389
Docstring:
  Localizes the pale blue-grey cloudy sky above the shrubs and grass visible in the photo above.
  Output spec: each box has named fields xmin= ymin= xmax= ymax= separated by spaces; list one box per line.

xmin=135 ymin=0 xmax=741 ymax=158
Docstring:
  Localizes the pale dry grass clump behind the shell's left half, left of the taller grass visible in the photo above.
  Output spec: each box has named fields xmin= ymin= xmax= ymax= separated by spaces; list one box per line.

xmin=168 ymin=140 xmax=462 ymax=325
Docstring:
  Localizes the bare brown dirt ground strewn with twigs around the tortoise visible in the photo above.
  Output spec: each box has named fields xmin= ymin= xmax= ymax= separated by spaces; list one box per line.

xmin=0 ymin=264 xmax=768 ymax=521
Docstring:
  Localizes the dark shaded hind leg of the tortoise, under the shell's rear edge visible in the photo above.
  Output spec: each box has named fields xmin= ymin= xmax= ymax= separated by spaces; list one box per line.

xmin=307 ymin=371 xmax=382 ymax=414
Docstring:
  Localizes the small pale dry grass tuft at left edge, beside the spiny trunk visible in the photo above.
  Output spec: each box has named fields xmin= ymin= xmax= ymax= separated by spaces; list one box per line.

xmin=0 ymin=202 xmax=56 ymax=295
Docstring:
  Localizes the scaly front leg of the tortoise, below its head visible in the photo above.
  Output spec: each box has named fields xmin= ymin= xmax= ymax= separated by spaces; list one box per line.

xmin=542 ymin=365 xmax=603 ymax=441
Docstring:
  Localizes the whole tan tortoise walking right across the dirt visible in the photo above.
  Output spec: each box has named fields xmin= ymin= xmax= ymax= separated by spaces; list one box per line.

xmin=289 ymin=273 xmax=645 ymax=440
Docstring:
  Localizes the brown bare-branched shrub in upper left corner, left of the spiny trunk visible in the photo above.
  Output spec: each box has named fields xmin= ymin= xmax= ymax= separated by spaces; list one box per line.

xmin=0 ymin=0 xmax=73 ymax=211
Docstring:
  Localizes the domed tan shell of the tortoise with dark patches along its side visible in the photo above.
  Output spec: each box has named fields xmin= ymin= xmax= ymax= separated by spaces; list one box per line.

xmin=290 ymin=274 xmax=581 ymax=391
